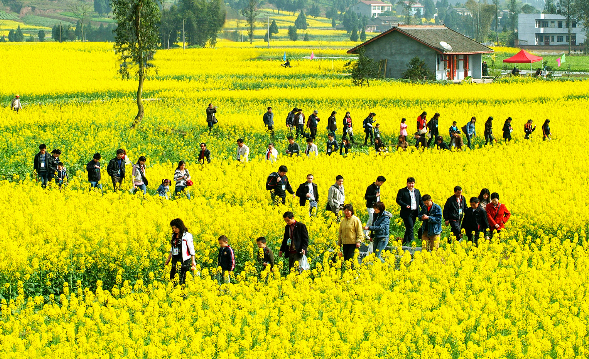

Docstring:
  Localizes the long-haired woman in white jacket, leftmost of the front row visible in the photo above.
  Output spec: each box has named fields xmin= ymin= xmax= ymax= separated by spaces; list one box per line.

xmin=165 ymin=218 xmax=196 ymax=285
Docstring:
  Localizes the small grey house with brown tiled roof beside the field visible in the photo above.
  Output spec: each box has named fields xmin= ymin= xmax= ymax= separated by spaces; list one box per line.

xmin=348 ymin=25 xmax=493 ymax=80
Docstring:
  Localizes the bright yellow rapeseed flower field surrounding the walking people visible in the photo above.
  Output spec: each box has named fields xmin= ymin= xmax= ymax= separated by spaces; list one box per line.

xmin=0 ymin=42 xmax=589 ymax=358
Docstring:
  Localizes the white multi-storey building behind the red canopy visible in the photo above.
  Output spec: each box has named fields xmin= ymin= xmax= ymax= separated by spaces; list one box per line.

xmin=517 ymin=14 xmax=585 ymax=46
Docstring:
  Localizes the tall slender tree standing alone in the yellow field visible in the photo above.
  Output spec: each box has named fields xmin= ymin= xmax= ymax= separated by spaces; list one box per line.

xmin=111 ymin=0 xmax=160 ymax=128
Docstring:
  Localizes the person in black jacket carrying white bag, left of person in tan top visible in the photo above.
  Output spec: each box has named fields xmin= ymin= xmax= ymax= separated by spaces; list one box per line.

xmin=278 ymin=212 xmax=309 ymax=269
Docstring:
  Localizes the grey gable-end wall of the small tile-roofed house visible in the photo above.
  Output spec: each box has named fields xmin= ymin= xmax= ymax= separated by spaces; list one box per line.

xmin=364 ymin=32 xmax=437 ymax=78
